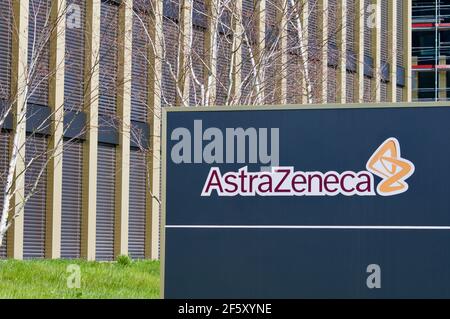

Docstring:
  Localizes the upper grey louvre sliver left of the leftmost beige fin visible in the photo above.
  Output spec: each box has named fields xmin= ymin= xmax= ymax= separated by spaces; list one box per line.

xmin=0 ymin=0 xmax=12 ymax=100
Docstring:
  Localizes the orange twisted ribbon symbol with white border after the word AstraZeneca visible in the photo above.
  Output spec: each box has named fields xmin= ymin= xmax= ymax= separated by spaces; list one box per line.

xmin=366 ymin=137 xmax=414 ymax=196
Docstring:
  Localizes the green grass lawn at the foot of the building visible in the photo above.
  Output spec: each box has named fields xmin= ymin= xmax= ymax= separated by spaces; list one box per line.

xmin=0 ymin=260 xmax=159 ymax=298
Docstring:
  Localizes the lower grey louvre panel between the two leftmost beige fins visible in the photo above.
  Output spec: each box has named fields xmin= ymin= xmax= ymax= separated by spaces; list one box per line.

xmin=23 ymin=136 xmax=47 ymax=258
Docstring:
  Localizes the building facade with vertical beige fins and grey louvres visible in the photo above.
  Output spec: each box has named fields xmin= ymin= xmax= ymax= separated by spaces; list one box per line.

xmin=0 ymin=0 xmax=412 ymax=260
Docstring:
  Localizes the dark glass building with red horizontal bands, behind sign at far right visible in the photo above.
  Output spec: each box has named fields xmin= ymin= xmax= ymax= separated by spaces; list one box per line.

xmin=412 ymin=0 xmax=450 ymax=101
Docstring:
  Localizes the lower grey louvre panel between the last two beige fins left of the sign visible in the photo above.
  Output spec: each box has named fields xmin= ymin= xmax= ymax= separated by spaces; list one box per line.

xmin=128 ymin=149 xmax=147 ymax=259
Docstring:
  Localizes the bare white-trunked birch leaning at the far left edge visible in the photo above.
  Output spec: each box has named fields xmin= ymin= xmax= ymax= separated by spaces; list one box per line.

xmin=0 ymin=0 xmax=120 ymax=247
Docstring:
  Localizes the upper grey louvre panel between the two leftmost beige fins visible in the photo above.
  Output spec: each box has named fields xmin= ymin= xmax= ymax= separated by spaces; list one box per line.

xmin=28 ymin=0 xmax=50 ymax=106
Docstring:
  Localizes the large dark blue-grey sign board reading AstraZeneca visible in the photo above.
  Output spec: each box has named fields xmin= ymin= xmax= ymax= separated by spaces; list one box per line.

xmin=161 ymin=104 xmax=450 ymax=298
